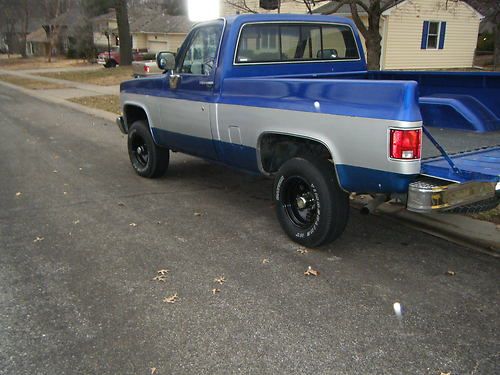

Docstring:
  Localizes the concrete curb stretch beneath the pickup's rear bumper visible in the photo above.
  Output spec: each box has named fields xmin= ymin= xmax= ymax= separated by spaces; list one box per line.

xmin=353 ymin=197 xmax=500 ymax=258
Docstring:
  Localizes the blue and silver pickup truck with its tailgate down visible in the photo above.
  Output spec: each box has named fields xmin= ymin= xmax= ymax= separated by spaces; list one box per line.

xmin=117 ymin=14 xmax=500 ymax=246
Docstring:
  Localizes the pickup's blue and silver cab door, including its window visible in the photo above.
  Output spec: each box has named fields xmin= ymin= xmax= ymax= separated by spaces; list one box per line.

xmin=160 ymin=20 xmax=224 ymax=159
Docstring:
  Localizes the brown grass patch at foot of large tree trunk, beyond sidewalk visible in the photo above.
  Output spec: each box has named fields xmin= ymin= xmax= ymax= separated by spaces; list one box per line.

xmin=40 ymin=66 xmax=132 ymax=86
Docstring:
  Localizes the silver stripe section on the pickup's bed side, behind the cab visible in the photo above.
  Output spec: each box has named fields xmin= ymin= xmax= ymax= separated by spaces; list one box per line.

xmin=217 ymin=103 xmax=422 ymax=174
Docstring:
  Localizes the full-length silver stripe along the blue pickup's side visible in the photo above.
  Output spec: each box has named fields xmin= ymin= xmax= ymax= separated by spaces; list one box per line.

xmin=121 ymin=93 xmax=422 ymax=174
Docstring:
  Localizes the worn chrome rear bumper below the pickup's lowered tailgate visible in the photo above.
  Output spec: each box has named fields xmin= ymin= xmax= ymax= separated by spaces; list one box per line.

xmin=407 ymin=180 xmax=500 ymax=212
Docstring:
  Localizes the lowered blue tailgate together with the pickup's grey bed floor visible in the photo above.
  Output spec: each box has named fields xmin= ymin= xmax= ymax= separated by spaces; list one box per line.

xmin=422 ymin=128 xmax=500 ymax=182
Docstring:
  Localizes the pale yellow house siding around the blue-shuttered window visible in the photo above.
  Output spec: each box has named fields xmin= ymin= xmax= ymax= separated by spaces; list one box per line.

xmin=381 ymin=0 xmax=480 ymax=69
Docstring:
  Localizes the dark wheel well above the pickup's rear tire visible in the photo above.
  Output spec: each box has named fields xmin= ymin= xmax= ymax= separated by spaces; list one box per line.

xmin=259 ymin=134 xmax=332 ymax=174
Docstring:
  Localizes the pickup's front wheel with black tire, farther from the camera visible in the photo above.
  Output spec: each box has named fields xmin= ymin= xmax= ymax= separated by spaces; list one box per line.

xmin=127 ymin=121 xmax=170 ymax=178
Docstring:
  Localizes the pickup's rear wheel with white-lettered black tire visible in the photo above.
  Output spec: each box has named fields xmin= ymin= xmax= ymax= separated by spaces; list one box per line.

xmin=273 ymin=157 xmax=349 ymax=247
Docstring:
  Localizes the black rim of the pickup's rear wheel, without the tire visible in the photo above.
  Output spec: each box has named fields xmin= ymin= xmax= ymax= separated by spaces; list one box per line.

xmin=282 ymin=176 xmax=318 ymax=229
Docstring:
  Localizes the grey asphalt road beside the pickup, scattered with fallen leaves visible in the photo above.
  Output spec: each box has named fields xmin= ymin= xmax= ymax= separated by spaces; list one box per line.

xmin=0 ymin=86 xmax=500 ymax=375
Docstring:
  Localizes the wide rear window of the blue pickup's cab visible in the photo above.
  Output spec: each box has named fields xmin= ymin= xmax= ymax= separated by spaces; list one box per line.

xmin=235 ymin=23 xmax=359 ymax=64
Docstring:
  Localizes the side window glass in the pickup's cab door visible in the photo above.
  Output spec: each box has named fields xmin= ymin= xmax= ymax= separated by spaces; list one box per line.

xmin=179 ymin=23 xmax=223 ymax=75
